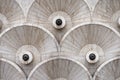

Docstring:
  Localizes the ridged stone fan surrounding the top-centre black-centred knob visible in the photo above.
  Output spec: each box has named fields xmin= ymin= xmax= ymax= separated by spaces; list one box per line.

xmin=28 ymin=0 xmax=90 ymax=41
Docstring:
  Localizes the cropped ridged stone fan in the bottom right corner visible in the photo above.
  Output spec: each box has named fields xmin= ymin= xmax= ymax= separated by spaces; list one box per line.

xmin=94 ymin=57 xmax=120 ymax=80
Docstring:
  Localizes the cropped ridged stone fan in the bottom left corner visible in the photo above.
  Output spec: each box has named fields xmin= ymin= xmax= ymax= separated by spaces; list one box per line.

xmin=0 ymin=59 xmax=26 ymax=80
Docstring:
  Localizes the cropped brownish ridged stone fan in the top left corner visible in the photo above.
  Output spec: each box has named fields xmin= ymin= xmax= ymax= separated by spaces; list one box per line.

xmin=0 ymin=0 xmax=24 ymax=31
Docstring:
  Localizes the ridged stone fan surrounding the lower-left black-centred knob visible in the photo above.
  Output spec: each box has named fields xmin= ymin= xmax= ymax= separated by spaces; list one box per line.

xmin=0 ymin=25 xmax=58 ymax=74
